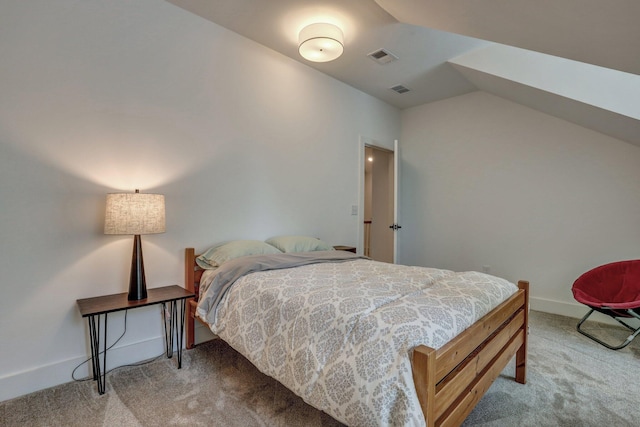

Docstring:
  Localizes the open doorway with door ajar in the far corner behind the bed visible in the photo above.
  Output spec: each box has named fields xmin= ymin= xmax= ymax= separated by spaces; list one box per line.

xmin=362 ymin=144 xmax=396 ymax=263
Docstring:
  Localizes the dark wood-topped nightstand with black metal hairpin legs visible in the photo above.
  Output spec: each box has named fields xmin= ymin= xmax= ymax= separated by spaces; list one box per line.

xmin=76 ymin=285 xmax=195 ymax=394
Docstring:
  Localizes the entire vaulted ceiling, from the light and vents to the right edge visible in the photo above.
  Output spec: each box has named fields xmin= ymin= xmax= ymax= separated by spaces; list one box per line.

xmin=167 ymin=0 xmax=640 ymax=145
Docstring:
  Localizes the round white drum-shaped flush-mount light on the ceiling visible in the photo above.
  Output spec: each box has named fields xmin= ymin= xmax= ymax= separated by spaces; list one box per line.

xmin=298 ymin=23 xmax=344 ymax=62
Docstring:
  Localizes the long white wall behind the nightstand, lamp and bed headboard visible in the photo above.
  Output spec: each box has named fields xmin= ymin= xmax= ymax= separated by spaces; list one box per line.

xmin=0 ymin=0 xmax=400 ymax=400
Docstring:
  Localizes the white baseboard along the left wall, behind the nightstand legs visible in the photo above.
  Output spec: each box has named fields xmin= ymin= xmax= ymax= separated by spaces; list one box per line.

xmin=0 ymin=336 xmax=165 ymax=402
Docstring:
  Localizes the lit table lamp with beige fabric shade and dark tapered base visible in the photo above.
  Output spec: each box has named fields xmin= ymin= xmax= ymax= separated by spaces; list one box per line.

xmin=104 ymin=190 xmax=165 ymax=301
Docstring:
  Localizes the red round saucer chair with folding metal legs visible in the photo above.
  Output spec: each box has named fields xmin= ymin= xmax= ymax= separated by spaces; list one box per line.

xmin=571 ymin=260 xmax=640 ymax=350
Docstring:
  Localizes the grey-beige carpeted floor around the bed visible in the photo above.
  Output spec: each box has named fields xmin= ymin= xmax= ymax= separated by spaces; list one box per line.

xmin=0 ymin=312 xmax=640 ymax=427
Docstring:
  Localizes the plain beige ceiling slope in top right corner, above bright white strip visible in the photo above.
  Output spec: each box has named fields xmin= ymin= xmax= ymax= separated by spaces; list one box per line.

xmin=375 ymin=0 xmax=640 ymax=74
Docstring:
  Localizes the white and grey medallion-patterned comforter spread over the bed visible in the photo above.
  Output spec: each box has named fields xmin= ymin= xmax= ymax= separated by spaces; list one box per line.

xmin=198 ymin=259 xmax=517 ymax=426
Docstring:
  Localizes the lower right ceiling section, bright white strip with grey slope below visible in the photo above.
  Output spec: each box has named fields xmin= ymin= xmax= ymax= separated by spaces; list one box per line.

xmin=449 ymin=44 xmax=640 ymax=145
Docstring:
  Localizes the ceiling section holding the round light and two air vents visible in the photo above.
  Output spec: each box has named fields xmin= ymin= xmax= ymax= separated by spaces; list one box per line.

xmin=167 ymin=0 xmax=489 ymax=108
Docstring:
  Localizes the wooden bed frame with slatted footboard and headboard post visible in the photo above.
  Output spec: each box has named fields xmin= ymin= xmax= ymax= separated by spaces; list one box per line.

xmin=185 ymin=248 xmax=529 ymax=427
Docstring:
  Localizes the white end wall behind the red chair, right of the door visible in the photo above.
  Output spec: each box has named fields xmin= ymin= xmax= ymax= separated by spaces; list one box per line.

xmin=400 ymin=92 xmax=640 ymax=316
